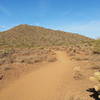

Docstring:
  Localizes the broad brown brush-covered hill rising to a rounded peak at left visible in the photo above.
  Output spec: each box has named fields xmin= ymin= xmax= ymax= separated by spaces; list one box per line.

xmin=0 ymin=24 xmax=91 ymax=47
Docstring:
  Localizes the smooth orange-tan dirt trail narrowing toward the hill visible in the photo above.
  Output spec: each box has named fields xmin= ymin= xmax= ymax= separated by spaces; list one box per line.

xmin=0 ymin=51 xmax=73 ymax=100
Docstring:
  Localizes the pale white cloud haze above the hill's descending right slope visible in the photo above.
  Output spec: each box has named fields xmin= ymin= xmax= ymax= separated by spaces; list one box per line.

xmin=63 ymin=21 xmax=100 ymax=38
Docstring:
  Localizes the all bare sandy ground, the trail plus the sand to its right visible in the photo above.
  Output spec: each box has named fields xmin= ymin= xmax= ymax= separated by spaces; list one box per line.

xmin=0 ymin=51 xmax=92 ymax=100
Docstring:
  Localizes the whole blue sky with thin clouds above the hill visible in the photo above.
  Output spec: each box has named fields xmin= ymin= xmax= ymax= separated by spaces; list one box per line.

xmin=0 ymin=0 xmax=100 ymax=38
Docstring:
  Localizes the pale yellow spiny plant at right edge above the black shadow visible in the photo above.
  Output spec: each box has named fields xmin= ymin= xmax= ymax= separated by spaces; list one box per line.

xmin=90 ymin=72 xmax=100 ymax=98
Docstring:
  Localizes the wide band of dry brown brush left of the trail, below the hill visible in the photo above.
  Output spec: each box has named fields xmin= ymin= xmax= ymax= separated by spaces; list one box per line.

xmin=0 ymin=48 xmax=56 ymax=65
